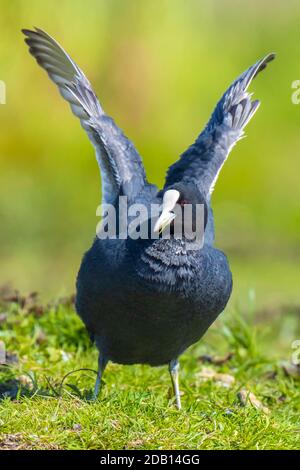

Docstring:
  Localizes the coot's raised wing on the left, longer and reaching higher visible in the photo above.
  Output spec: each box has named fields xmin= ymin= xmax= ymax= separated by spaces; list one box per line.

xmin=22 ymin=28 xmax=146 ymax=203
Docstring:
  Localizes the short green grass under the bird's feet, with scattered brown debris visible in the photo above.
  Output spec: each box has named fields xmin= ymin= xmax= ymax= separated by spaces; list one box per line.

xmin=0 ymin=288 xmax=300 ymax=449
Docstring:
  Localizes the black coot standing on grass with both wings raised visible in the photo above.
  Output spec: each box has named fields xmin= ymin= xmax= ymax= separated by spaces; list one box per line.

xmin=23 ymin=28 xmax=274 ymax=408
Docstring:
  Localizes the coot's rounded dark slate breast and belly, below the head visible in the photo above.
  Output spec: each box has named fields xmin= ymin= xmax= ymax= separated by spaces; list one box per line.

xmin=77 ymin=240 xmax=232 ymax=365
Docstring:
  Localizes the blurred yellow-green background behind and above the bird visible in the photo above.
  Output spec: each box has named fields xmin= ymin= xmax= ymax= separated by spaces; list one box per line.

xmin=0 ymin=0 xmax=300 ymax=312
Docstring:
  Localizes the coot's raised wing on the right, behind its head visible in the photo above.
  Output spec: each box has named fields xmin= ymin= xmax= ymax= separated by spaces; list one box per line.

xmin=165 ymin=54 xmax=275 ymax=198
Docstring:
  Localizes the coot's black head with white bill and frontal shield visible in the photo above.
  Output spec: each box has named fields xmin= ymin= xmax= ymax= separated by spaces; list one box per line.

xmin=154 ymin=182 xmax=207 ymax=239
